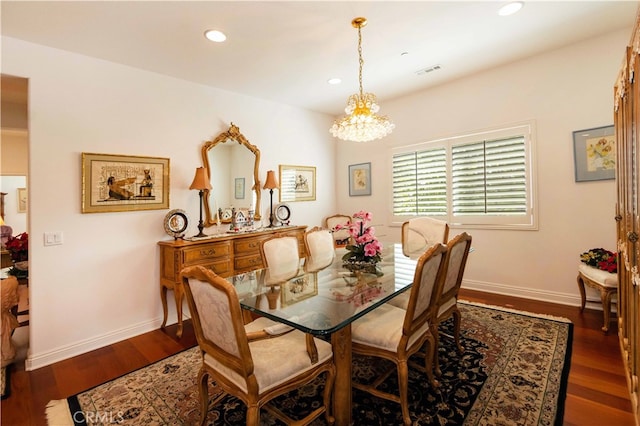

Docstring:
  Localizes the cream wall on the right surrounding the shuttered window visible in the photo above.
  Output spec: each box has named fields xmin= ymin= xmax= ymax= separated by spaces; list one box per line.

xmin=336 ymin=28 xmax=631 ymax=305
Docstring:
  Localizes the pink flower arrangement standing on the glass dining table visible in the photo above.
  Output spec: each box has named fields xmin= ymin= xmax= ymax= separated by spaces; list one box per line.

xmin=335 ymin=210 xmax=382 ymax=263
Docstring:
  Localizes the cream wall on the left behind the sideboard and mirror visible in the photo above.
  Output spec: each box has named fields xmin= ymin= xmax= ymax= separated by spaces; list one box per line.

xmin=2 ymin=37 xmax=335 ymax=368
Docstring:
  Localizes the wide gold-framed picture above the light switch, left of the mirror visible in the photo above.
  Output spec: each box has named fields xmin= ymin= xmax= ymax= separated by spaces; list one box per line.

xmin=82 ymin=152 xmax=169 ymax=213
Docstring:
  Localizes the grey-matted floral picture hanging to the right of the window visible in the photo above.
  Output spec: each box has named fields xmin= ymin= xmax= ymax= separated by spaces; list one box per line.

xmin=573 ymin=125 xmax=616 ymax=182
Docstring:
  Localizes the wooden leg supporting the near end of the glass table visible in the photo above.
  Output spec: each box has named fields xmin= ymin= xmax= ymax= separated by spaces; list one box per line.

xmin=331 ymin=324 xmax=351 ymax=426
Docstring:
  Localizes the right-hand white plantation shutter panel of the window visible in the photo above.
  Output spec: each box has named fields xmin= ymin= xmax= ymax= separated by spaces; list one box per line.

xmin=451 ymin=136 xmax=527 ymax=215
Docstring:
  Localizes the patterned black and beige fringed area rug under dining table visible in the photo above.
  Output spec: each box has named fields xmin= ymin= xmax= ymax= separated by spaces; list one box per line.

xmin=47 ymin=303 xmax=573 ymax=426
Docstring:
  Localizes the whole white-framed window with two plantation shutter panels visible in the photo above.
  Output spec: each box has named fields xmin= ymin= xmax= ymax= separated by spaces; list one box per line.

xmin=392 ymin=122 xmax=537 ymax=229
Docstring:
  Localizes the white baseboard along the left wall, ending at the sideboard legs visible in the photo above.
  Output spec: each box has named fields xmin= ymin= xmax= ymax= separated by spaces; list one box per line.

xmin=25 ymin=318 xmax=162 ymax=371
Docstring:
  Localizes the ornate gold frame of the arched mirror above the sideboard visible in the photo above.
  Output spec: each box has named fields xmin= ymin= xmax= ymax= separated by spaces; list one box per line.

xmin=202 ymin=123 xmax=261 ymax=227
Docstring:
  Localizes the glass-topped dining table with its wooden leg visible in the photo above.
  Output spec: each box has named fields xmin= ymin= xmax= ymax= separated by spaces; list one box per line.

xmin=232 ymin=243 xmax=417 ymax=426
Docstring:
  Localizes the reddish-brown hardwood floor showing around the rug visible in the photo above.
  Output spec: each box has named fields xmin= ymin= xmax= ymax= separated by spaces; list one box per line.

xmin=1 ymin=289 xmax=635 ymax=426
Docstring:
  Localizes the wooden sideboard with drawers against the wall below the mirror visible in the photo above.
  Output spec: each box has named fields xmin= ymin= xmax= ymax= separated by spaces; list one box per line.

xmin=158 ymin=226 xmax=307 ymax=337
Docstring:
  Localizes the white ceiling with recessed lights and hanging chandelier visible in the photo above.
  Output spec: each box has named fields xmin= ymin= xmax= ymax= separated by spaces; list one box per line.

xmin=0 ymin=0 xmax=638 ymax=116
